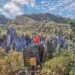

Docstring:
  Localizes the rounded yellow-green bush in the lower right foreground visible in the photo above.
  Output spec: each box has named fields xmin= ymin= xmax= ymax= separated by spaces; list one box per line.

xmin=42 ymin=52 xmax=75 ymax=75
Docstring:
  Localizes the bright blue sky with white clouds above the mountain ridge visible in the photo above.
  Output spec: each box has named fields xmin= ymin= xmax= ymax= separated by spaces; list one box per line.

xmin=0 ymin=0 xmax=75 ymax=18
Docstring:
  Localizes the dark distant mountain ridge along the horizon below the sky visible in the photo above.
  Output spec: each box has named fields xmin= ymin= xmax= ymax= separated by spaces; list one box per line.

xmin=0 ymin=13 xmax=72 ymax=25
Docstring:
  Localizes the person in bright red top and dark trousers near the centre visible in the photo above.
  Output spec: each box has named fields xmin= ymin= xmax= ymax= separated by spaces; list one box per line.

xmin=33 ymin=35 xmax=44 ymax=69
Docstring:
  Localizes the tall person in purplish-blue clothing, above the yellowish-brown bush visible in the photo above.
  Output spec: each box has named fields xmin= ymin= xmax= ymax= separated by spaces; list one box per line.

xmin=6 ymin=28 xmax=17 ymax=52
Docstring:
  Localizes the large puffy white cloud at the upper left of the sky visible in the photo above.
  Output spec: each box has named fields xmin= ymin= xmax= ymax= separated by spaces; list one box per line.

xmin=0 ymin=0 xmax=35 ymax=17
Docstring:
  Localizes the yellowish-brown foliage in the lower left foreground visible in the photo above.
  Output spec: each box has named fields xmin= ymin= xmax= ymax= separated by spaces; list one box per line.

xmin=0 ymin=49 xmax=24 ymax=75
